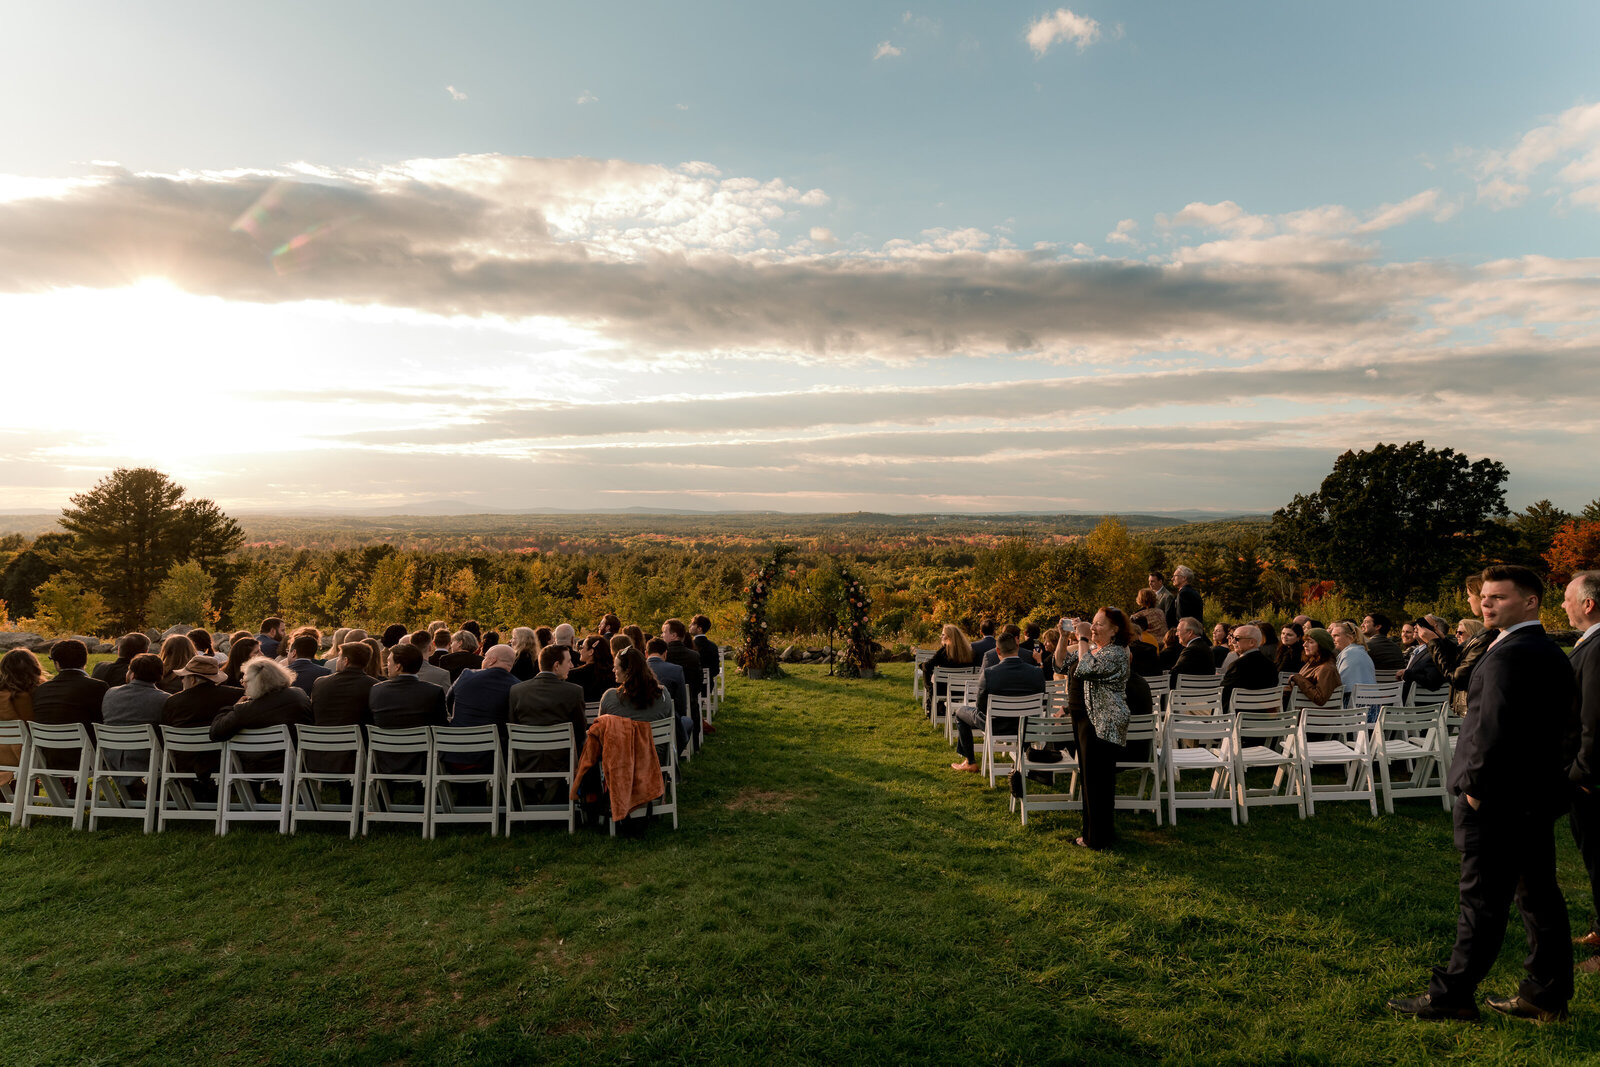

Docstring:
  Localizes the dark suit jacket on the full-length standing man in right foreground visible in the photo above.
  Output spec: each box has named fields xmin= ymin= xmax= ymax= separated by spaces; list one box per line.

xmin=1450 ymin=624 xmax=1578 ymax=817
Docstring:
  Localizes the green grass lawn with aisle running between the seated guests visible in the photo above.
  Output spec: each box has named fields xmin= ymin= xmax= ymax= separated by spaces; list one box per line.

xmin=0 ymin=664 xmax=1600 ymax=1064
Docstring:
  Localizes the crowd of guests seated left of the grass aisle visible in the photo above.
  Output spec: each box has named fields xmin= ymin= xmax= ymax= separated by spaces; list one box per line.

xmin=0 ymin=614 xmax=722 ymax=825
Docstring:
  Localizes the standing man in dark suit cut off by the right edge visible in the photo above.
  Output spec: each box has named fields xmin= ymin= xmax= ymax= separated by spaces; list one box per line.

xmin=1562 ymin=571 xmax=1600 ymax=974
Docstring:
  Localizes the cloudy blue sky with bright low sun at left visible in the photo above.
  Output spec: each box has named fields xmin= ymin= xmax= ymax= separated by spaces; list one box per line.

xmin=0 ymin=0 xmax=1600 ymax=514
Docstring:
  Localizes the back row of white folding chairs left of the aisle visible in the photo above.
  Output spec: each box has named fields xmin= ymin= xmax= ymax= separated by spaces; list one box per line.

xmin=0 ymin=720 xmax=678 ymax=838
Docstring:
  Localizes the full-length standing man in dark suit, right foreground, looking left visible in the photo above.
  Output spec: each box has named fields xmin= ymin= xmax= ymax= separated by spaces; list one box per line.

xmin=1389 ymin=565 xmax=1576 ymax=1022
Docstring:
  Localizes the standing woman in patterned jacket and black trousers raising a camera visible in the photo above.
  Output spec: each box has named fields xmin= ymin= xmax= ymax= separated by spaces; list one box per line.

xmin=1056 ymin=606 xmax=1133 ymax=849
